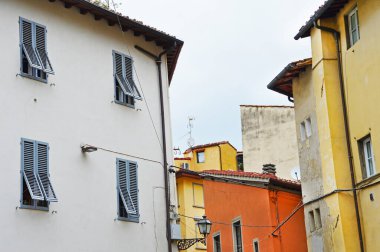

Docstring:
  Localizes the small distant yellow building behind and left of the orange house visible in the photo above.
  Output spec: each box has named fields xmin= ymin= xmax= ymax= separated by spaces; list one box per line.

xmin=174 ymin=141 xmax=237 ymax=252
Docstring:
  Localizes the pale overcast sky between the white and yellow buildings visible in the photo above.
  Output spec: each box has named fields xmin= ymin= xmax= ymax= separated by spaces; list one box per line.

xmin=121 ymin=0 xmax=323 ymax=154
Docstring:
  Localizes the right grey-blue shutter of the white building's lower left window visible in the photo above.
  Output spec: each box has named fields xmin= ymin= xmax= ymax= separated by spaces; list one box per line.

xmin=36 ymin=142 xmax=58 ymax=202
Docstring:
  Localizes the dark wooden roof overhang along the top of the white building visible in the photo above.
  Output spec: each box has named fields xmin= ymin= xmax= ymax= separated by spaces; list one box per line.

xmin=49 ymin=0 xmax=184 ymax=82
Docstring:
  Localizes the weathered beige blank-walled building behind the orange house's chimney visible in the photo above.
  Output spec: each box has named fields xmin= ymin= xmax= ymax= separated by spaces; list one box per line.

xmin=240 ymin=105 xmax=300 ymax=179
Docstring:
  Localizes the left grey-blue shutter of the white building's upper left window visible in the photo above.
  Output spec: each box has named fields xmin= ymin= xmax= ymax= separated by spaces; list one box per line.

xmin=20 ymin=20 xmax=42 ymax=70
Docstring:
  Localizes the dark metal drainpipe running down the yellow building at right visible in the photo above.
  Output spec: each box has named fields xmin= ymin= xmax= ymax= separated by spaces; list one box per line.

xmin=314 ymin=22 xmax=365 ymax=252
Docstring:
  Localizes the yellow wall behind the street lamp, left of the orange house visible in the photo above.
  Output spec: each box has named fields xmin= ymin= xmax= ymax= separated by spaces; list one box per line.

xmin=177 ymin=177 xmax=206 ymax=252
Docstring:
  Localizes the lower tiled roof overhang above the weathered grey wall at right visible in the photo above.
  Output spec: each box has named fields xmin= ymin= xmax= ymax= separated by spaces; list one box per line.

xmin=267 ymin=58 xmax=312 ymax=97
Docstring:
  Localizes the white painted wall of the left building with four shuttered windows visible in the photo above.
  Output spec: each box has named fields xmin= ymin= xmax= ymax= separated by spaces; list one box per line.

xmin=0 ymin=0 xmax=175 ymax=252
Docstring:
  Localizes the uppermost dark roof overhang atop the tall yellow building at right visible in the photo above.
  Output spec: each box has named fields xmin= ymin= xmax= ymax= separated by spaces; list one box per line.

xmin=294 ymin=0 xmax=349 ymax=40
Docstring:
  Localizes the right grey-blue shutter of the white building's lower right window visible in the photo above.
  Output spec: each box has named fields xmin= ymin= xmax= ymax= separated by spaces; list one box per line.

xmin=128 ymin=161 xmax=140 ymax=222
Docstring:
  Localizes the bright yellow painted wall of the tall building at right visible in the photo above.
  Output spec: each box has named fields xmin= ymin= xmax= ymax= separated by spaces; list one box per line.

xmin=294 ymin=0 xmax=380 ymax=251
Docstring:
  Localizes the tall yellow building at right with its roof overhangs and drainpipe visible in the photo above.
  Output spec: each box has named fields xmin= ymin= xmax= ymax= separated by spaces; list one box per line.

xmin=268 ymin=0 xmax=380 ymax=252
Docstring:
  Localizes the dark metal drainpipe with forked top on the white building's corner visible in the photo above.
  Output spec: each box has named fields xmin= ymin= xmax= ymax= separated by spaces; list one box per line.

xmin=135 ymin=45 xmax=175 ymax=252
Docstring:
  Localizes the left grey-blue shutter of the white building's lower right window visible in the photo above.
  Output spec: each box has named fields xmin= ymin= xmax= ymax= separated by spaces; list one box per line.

xmin=117 ymin=159 xmax=137 ymax=215
